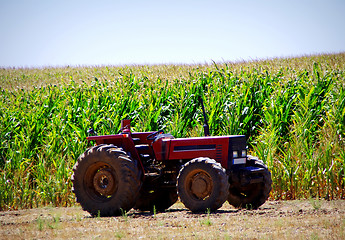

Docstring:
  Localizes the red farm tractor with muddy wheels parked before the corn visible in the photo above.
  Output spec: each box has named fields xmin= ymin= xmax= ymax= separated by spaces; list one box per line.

xmin=72 ymin=102 xmax=272 ymax=216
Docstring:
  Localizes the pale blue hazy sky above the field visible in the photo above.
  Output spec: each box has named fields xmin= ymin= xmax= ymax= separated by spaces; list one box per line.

xmin=0 ymin=0 xmax=345 ymax=68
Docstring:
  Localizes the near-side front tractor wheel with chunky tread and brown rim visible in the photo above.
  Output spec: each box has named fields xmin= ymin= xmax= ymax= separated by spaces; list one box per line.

xmin=177 ymin=157 xmax=229 ymax=212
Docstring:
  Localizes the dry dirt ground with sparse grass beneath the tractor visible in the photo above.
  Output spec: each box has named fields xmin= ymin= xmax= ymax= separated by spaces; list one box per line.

xmin=0 ymin=200 xmax=345 ymax=239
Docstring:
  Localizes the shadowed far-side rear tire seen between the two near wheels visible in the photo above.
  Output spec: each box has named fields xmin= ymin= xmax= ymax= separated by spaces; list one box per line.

xmin=134 ymin=184 xmax=178 ymax=212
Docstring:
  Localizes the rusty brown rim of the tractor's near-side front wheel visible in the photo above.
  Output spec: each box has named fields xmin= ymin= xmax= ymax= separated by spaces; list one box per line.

xmin=186 ymin=169 xmax=213 ymax=200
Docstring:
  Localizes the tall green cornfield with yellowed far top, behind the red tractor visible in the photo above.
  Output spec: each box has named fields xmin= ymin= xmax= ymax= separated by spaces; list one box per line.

xmin=0 ymin=53 xmax=345 ymax=210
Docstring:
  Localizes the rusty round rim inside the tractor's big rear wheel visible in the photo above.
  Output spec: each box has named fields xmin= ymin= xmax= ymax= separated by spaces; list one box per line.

xmin=84 ymin=162 xmax=118 ymax=201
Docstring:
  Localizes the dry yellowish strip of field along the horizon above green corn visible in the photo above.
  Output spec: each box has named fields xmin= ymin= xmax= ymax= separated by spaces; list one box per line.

xmin=0 ymin=52 xmax=345 ymax=90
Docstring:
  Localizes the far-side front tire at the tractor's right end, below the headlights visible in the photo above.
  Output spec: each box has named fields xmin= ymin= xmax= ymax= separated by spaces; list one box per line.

xmin=228 ymin=156 xmax=272 ymax=209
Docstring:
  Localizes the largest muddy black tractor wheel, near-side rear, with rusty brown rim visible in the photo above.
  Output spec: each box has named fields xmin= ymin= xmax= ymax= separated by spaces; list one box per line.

xmin=72 ymin=144 xmax=141 ymax=216
